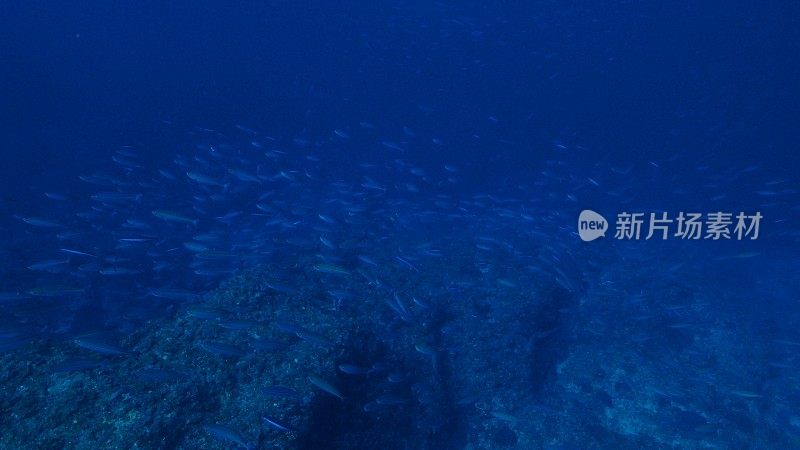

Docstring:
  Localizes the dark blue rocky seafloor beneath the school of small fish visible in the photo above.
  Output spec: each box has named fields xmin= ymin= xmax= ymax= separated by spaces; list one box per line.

xmin=0 ymin=227 xmax=800 ymax=449
